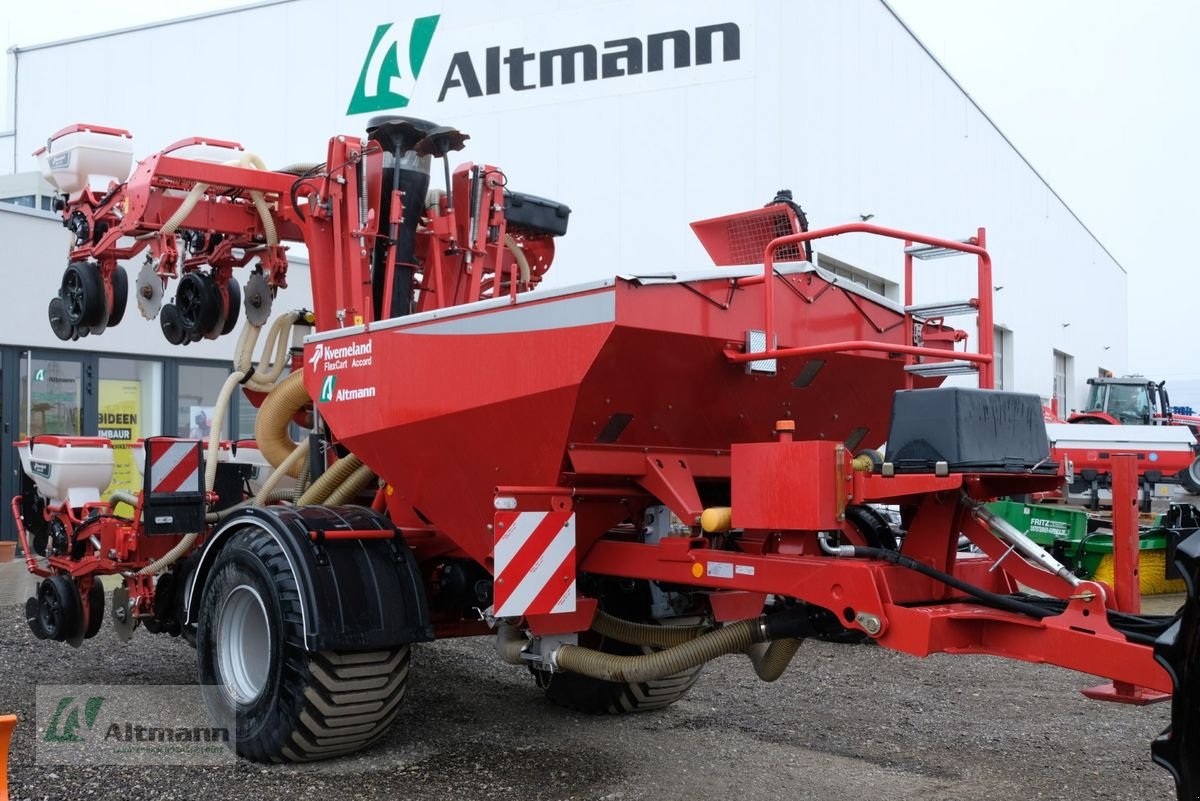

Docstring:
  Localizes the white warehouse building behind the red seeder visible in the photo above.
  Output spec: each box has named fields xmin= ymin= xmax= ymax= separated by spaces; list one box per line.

xmin=0 ymin=0 xmax=1128 ymax=536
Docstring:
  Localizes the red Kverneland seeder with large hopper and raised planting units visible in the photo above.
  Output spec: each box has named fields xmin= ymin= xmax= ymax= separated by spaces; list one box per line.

xmin=13 ymin=118 xmax=1200 ymax=799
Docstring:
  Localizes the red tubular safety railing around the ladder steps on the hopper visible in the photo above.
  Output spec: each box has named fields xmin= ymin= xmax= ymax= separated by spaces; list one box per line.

xmin=728 ymin=223 xmax=995 ymax=389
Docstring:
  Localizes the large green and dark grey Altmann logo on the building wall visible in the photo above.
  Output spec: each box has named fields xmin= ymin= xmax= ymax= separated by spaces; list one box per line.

xmin=346 ymin=17 xmax=742 ymax=114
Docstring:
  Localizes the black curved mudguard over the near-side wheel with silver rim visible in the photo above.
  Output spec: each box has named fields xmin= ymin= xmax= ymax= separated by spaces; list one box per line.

xmin=185 ymin=506 xmax=433 ymax=651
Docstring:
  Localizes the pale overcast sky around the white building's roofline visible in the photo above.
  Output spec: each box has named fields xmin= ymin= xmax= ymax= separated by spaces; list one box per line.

xmin=0 ymin=0 xmax=1200 ymax=408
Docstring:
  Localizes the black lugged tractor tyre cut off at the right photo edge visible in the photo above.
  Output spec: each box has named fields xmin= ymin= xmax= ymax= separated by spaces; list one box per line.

xmin=1151 ymin=532 xmax=1200 ymax=801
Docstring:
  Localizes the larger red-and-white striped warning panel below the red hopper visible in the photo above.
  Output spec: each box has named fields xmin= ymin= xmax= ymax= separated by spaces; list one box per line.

xmin=493 ymin=512 xmax=575 ymax=618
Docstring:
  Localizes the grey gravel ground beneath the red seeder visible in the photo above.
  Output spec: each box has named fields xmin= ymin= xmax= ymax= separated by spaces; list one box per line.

xmin=0 ymin=606 xmax=1175 ymax=801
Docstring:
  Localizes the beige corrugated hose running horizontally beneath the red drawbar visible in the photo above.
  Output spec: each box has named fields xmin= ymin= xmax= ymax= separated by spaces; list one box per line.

xmin=550 ymin=619 xmax=766 ymax=683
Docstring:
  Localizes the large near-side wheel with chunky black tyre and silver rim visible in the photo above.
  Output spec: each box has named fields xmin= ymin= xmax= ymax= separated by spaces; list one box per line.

xmin=196 ymin=530 xmax=410 ymax=763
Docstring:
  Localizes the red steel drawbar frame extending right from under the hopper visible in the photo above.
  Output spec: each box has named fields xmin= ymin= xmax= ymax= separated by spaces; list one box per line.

xmin=564 ymin=442 xmax=1171 ymax=700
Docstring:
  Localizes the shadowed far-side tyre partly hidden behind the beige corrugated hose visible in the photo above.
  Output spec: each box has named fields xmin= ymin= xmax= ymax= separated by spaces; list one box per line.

xmin=529 ymin=620 xmax=703 ymax=715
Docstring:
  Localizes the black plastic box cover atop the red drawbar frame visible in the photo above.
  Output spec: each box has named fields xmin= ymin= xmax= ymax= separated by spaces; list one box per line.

xmin=884 ymin=387 xmax=1058 ymax=474
